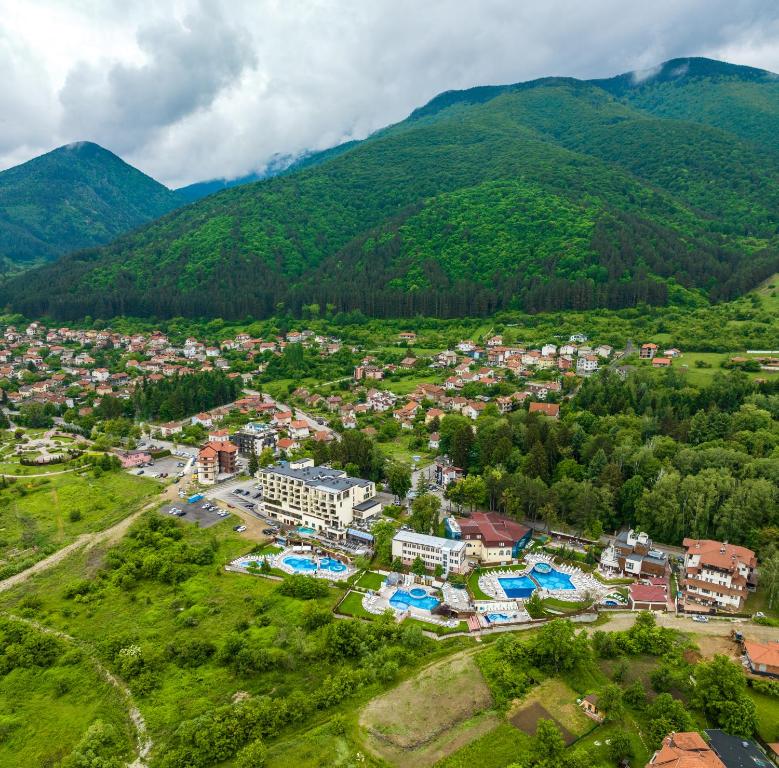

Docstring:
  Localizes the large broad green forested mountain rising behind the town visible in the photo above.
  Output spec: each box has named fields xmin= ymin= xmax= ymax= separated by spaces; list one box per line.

xmin=0 ymin=59 xmax=779 ymax=319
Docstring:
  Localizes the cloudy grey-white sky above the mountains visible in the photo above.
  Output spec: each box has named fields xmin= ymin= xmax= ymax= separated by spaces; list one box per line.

xmin=0 ymin=0 xmax=779 ymax=187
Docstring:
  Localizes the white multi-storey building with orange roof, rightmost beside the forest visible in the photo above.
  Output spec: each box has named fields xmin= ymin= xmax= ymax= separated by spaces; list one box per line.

xmin=682 ymin=539 xmax=757 ymax=611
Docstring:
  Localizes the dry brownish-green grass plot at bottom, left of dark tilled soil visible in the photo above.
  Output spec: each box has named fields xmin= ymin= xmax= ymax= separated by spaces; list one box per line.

xmin=360 ymin=651 xmax=498 ymax=768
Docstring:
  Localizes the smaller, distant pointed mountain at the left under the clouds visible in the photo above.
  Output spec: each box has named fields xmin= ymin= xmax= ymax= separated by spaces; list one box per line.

xmin=0 ymin=142 xmax=179 ymax=272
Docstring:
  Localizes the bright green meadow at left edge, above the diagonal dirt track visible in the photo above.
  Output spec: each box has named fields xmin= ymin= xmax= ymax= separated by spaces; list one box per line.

xmin=0 ymin=472 xmax=160 ymax=577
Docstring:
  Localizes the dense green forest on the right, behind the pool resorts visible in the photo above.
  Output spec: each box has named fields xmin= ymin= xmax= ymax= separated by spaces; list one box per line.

xmin=440 ymin=369 xmax=779 ymax=558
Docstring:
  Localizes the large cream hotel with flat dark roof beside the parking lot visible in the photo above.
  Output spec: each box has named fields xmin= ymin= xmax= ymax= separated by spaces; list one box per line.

xmin=257 ymin=459 xmax=381 ymax=539
